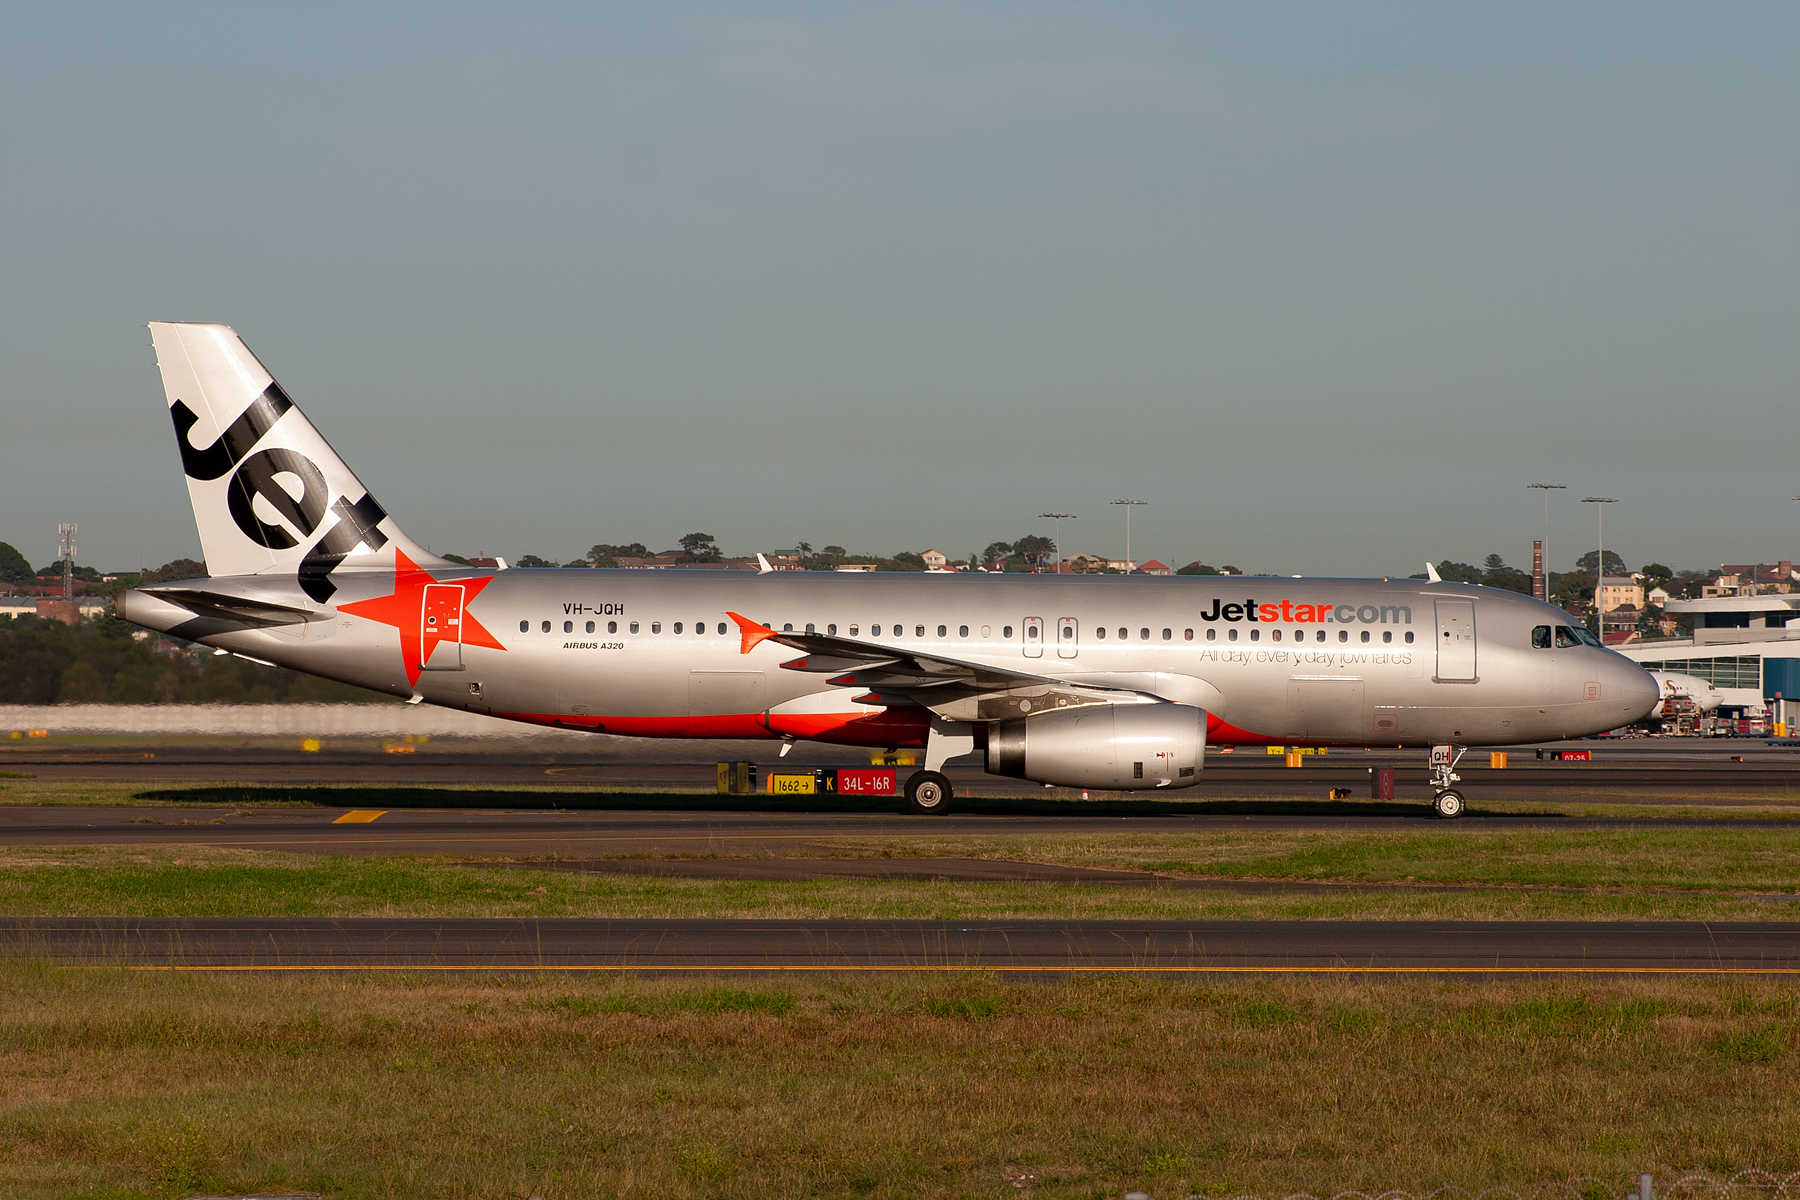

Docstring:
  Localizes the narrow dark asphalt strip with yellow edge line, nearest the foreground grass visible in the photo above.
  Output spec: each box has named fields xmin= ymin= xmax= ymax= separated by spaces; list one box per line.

xmin=14 ymin=918 xmax=1800 ymax=975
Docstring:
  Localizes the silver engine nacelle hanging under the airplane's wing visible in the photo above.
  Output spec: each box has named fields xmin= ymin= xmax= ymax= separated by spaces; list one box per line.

xmin=988 ymin=703 xmax=1206 ymax=790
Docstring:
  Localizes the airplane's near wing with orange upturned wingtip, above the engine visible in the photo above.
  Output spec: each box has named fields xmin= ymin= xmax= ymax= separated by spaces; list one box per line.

xmin=727 ymin=613 xmax=1161 ymax=721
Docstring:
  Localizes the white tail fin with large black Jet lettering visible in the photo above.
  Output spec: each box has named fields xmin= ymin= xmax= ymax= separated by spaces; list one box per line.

xmin=149 ymin=322 xmax=450 ymax=604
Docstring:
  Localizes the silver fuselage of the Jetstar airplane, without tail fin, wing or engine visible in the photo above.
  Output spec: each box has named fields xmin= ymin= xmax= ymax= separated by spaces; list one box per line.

xmin=119 ymin=569 xmax=1658 ymax=747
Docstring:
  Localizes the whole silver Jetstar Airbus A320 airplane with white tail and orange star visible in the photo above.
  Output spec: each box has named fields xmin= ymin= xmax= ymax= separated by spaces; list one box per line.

xmin=115 ymin=322 xmax=1661 ymax=817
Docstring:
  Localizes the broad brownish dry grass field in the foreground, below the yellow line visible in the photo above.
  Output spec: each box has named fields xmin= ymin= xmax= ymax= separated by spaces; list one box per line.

xmin=0 ymin=964 xmax=1800 ymax=1200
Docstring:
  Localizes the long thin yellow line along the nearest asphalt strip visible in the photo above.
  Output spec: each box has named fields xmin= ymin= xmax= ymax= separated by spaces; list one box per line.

xmin=126 ymin=963 xmax=1800 ymax=975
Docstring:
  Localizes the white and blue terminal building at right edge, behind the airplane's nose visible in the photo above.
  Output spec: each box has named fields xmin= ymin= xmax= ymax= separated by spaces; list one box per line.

xmin=1615 ymin=594 xmax=1800 ymax=716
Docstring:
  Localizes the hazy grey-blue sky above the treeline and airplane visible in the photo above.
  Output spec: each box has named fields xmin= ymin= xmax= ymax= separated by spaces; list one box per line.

xmin=0 ymin=0 xmax=1800 ymax=576
